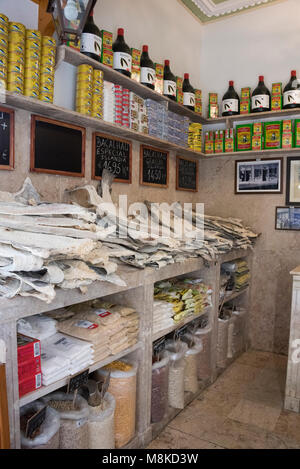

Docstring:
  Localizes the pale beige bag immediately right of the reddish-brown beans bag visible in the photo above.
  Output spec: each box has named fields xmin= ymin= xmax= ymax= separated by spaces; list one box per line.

xmin=165 ymin=340 xmax=188 ymax=409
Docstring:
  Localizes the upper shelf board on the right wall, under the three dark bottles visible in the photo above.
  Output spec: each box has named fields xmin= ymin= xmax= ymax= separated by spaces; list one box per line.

xmin=205 ymin=108 xmax=300 ymax=126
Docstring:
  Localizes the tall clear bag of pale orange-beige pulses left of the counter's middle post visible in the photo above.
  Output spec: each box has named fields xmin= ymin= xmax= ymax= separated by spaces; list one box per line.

xmin=94 ymin=360 xmax=137 ymax=448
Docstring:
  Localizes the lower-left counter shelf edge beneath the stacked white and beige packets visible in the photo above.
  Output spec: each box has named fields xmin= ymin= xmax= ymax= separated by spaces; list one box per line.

xmin=19 ymin=342 xmax=141 ymax=407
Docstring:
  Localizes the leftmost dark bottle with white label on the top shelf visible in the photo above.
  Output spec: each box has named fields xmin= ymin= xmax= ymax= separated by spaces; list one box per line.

xmin=80 ymin=9 xmax=102 ymax=62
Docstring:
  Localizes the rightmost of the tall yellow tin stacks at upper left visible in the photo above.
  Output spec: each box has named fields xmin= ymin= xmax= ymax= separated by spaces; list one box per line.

xmin=40 ymin=36 xmax=56 ymax=103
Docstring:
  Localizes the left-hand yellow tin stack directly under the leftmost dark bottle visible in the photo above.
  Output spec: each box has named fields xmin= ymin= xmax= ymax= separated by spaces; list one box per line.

xmin=76 ymin=64 xmax=93 ymax=116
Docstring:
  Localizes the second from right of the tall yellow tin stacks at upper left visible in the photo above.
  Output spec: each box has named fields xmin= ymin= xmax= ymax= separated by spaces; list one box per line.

xmin=24 ymin=29 xmax=42 ymax=99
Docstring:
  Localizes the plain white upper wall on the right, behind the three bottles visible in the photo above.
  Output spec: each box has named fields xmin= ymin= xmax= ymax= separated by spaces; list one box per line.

xmin=201 ymin=0 xmax=300 ymax=109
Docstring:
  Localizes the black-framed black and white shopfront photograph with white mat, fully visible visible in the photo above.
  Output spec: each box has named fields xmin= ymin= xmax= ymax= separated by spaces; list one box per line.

xmin=235 ymin=158 xmax=283 ymax=194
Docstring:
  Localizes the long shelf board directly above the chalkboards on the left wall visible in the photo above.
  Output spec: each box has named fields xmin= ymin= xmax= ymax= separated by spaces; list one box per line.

xmin=1 ymin=91 xmax=204 ymax=158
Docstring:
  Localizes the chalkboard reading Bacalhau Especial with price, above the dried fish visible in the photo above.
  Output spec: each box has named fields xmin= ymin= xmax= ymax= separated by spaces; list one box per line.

xmin=92 ymin=132 xmax=132 ymax=184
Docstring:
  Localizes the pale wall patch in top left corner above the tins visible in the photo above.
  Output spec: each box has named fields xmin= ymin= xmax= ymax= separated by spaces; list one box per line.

xmin=0 ymin=0 xmax=39 ymax=29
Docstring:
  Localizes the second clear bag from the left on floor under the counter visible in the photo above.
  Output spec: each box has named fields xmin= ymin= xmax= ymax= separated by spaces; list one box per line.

xmin=42 ymin=392 xmax=89 ymax=449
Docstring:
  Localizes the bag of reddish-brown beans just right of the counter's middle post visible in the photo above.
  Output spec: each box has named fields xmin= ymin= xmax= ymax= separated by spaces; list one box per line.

xmin=151 ymin=353 xmax=170 ymax=423
